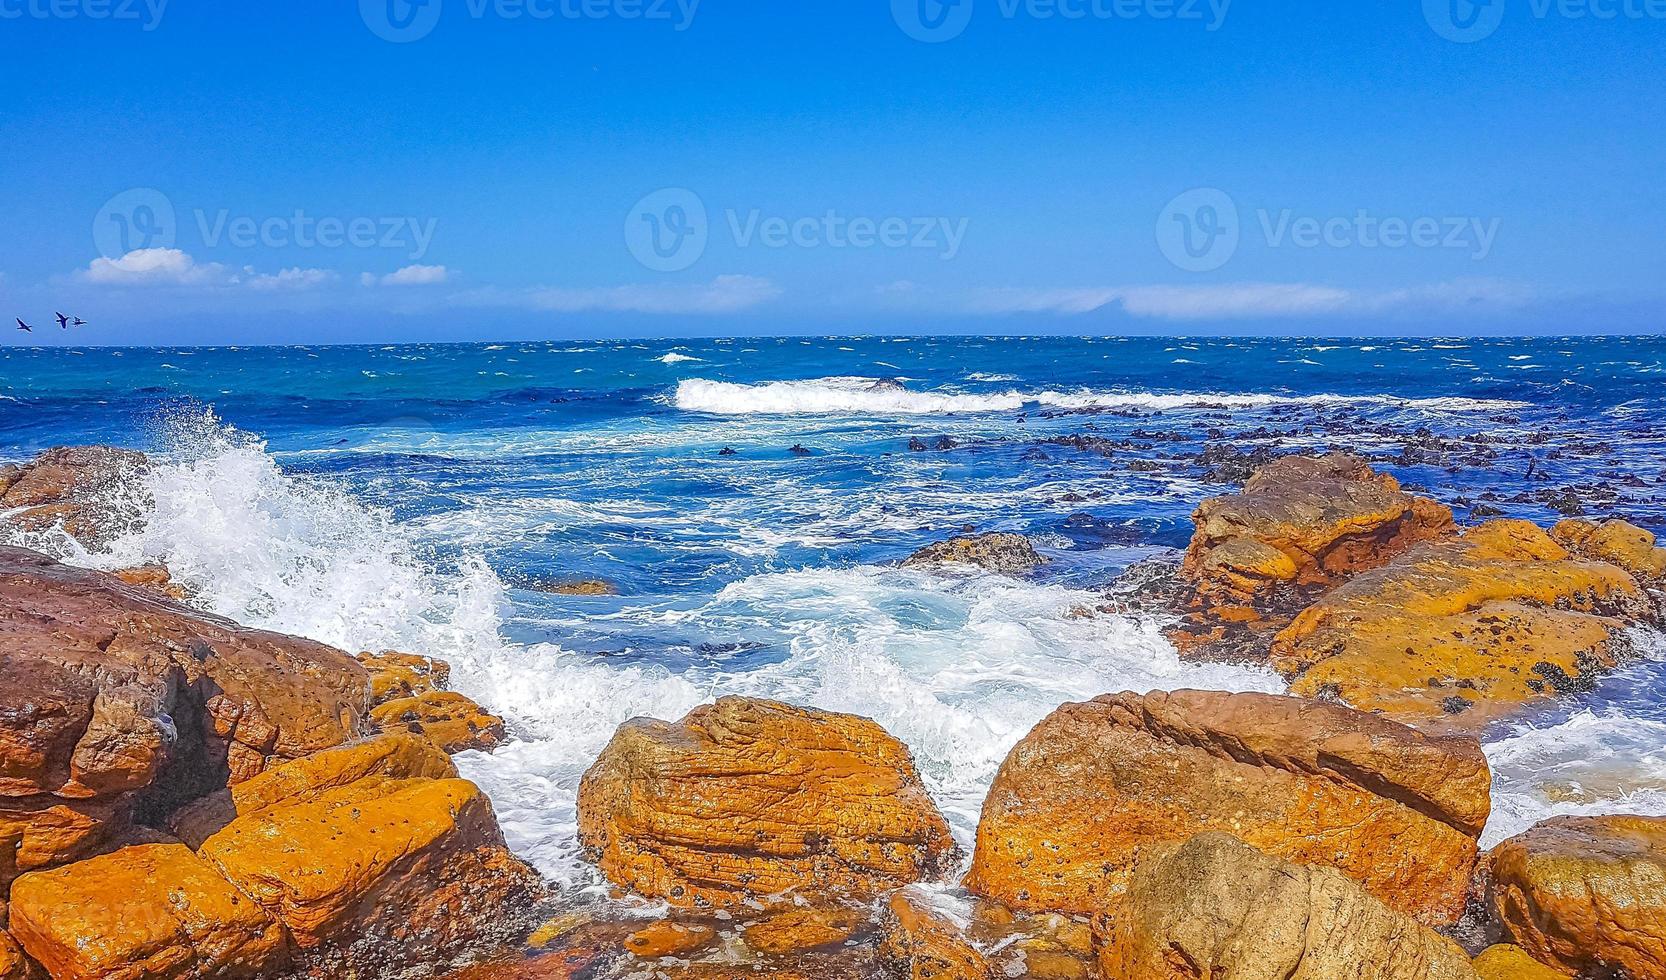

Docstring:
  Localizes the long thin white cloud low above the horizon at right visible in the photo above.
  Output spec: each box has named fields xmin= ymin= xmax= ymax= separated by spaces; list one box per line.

xmin=961 ymin=280 xmax=1534 ymax=320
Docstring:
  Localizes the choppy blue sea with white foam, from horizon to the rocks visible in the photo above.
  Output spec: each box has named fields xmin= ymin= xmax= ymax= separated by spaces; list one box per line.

xmin=0 ymin=338 xmax=1666 ymax=887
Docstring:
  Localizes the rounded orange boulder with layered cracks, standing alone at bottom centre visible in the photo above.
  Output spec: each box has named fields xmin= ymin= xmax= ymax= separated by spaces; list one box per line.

xmin=578 ymin=698 xmax=955 ymax=907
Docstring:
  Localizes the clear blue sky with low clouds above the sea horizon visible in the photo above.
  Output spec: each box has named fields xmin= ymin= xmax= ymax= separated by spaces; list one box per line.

xmin=0 ymin=0 xmax=1666 ymax=343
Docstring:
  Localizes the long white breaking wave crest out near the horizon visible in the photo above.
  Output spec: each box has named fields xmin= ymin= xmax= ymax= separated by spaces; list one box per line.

xmin=671 ymin=377 xmax=1526 ymax=417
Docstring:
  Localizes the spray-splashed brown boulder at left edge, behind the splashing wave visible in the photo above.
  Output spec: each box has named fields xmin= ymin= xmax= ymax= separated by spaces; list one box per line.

xmin=0 ymin=445 xmax=148 ymax=547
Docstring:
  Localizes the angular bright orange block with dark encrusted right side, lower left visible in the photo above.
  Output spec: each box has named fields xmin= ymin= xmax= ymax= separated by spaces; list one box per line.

xmin=198 ymin=775 xmax=538 ymax=958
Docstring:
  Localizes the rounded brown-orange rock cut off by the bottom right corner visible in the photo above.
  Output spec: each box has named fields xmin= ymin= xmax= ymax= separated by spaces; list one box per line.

xmin=1486 ymin=815 xmax=1666 ymax=980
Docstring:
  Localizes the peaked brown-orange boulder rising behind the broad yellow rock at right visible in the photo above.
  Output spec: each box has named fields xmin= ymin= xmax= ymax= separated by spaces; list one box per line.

xmin=1170 ymin=453 xmax=1456 ymax=658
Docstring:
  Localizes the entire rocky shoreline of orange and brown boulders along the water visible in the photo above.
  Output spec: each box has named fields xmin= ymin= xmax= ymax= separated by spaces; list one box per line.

xmin=0 ymin=447 xmax=1666 ymax=980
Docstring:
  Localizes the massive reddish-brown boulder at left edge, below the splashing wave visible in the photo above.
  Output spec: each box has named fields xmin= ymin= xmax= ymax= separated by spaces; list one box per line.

xmin=0 ymin=546 xmax=368 ymax=887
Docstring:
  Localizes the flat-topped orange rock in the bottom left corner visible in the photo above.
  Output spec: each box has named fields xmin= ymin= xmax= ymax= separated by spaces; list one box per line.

xmin=12 ymin=843 xmax=290 ymax=980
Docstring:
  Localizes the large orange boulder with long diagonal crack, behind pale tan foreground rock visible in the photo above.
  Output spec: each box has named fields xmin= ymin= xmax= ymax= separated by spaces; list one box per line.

xmin=966 ymin=692 xmax=1491 ymax=923
